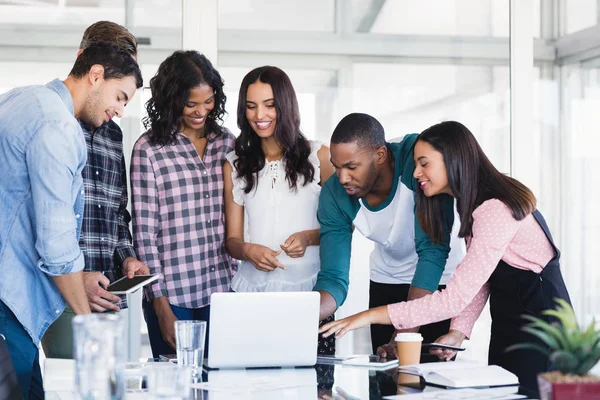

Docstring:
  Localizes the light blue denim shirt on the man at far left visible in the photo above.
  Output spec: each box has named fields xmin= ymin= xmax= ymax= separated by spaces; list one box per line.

xmin=0 ymin=79 xmax=87 ymax=345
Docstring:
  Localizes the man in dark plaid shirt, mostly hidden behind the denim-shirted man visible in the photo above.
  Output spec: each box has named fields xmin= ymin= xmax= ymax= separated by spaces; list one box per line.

xmin=42 ymin=21 xmax=150 ymax=358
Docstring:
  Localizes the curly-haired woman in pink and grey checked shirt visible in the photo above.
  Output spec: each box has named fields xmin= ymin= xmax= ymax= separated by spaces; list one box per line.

xmin=131 ymin=51 xmax=235 ymax=357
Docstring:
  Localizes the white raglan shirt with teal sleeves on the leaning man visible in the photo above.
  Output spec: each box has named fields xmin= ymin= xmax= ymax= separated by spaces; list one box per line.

xmin=314 ymin=134 xmax=454 ymax=307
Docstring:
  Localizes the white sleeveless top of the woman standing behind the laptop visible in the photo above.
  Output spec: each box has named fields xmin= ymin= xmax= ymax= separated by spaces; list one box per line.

xmin=227 ymin=141 xmax=322 ymax=292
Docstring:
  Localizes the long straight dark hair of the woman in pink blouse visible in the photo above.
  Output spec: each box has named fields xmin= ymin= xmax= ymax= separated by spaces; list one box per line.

xmin=417 ymin=121 xmax=536 ymax=242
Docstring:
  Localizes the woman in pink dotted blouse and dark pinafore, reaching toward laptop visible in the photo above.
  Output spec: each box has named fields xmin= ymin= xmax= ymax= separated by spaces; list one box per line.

xmin=320 ymin=121 xmax=570 ymax=392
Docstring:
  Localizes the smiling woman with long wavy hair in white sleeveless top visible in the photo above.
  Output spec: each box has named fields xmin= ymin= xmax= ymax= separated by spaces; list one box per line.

xmin=223 ymin=66 xmax=335 ymax=354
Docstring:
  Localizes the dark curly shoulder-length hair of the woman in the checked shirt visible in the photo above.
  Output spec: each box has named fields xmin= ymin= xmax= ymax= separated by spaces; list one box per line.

xmin=143 ymin=50 xmax=227 ymax=146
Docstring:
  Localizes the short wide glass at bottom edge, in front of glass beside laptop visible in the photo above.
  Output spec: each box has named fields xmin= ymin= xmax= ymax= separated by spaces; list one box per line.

xmin=146 ymin=363 xmax=192 ymax=400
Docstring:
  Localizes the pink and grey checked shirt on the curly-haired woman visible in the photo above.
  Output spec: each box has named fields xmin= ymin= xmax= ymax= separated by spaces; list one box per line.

xmin=131 ymin=131 xmax=235 ymax=308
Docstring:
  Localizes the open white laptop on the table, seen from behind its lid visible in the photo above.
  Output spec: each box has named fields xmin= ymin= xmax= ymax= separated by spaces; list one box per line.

xmin=208 ymin=292 xmax=320 ymax=368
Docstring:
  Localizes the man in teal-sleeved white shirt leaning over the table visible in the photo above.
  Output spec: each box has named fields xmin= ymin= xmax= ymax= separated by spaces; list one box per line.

xmin=314 ymin=113 xmax=464 ymax=352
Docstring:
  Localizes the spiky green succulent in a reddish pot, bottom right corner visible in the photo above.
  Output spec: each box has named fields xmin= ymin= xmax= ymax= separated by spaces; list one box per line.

xmin=507 ymin=299 xmax=600 ymax=400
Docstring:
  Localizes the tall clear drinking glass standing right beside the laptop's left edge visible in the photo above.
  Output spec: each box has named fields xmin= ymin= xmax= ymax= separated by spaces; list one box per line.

xmin=175 ymin=321 xmax=206 ymax=378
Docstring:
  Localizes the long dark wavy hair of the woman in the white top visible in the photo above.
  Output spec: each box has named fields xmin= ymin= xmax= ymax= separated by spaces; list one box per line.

xmin=233 ymin=66 xmax=315 ymax=193
